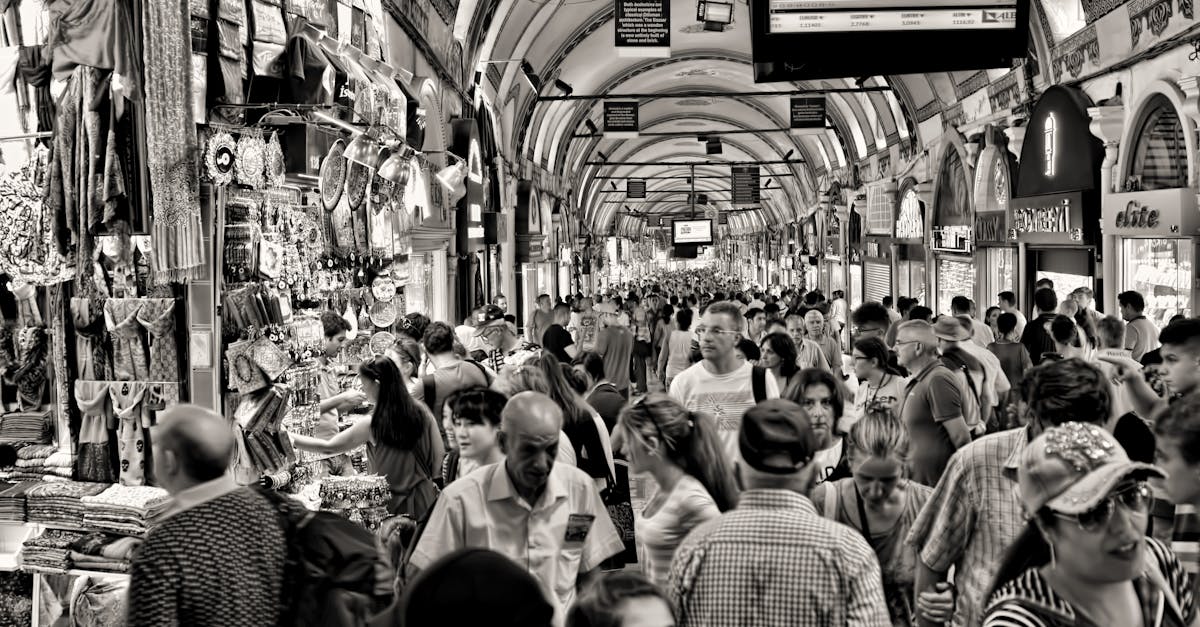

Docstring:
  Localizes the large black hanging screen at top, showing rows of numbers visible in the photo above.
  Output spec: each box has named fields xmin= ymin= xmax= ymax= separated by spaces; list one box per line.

xmin=750 ymin=0 xmax=1030 ymax=83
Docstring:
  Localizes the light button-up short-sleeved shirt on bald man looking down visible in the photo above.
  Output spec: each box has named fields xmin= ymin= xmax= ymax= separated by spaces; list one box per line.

xmin=410 ymin=461 xmax=625 ymax=625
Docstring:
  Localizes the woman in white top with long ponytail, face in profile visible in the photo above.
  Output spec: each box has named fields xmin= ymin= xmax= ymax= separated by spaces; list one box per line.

xmin=613 ymin=393 xmax=738 ymax=585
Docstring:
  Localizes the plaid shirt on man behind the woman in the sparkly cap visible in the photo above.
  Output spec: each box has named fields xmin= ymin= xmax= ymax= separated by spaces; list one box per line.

xmin=908 ymin=428 xmax=1028 ymax=627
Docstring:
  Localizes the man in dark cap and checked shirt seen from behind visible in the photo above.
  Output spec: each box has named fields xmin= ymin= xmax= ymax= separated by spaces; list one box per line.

xmin=667 ymin=399 xmax=890 ymax=627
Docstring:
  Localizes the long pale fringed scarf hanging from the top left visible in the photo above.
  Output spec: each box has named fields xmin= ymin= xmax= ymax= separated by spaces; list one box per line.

xmin=142 ymin=0 xmax=205 ymax=282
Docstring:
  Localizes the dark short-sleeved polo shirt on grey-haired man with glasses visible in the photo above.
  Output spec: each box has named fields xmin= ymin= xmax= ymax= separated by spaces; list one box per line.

xmin=900 ymin=363 xmax=962 ymax=485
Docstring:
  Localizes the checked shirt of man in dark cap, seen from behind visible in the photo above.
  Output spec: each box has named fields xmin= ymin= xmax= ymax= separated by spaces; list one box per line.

xmin=667 ymin=490 xmax=890 ymax=627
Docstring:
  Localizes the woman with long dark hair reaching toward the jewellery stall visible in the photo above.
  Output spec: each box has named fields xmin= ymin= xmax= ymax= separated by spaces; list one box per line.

xmin=292 ymin=357 xmax=445 ymax=520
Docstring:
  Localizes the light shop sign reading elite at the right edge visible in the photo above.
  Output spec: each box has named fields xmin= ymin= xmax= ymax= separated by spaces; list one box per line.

xmin=1104 ymin=189 xmax=1200 ymax=237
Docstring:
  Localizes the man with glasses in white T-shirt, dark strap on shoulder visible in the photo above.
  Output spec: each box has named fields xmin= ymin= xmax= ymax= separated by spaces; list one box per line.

xmin=671 ymin=300 xmax=779 ymax=461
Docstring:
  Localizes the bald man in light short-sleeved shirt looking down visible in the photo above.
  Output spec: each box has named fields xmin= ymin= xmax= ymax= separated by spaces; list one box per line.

xmin=409 ymin=392 xmax=624 ymax=625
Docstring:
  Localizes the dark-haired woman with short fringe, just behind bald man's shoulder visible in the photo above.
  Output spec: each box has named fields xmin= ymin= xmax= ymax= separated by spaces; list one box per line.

xmin=442 ymin=388 xmax=509 ymax=489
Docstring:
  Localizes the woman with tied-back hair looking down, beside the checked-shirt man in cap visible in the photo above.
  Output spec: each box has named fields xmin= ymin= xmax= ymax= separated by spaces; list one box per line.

xmin=811 ymin=405 xmax=934 ymax=627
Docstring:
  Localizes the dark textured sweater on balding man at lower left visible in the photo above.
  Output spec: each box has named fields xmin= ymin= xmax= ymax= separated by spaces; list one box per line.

xmin=126 ymin=488 xmax=295 ymax=627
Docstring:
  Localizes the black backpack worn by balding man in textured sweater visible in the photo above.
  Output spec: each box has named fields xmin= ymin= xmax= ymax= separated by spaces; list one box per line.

xmin=262 ymin=490 xmax=395 ymax=627
